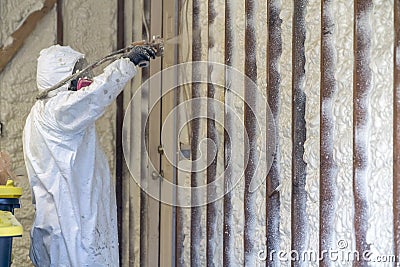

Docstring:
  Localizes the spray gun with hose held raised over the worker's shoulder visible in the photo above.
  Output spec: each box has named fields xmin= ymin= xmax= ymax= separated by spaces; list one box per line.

xmin=36 ymin=36 xmax=164 ymax=100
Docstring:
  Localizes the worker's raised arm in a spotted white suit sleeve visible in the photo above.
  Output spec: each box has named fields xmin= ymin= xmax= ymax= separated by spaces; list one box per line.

xmin=47 ymin=58 xmax=136 ymax=132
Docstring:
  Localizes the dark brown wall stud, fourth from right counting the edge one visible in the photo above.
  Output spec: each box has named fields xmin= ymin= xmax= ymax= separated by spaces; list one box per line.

xmin=291 ymin=0 xmax=308 ymax=266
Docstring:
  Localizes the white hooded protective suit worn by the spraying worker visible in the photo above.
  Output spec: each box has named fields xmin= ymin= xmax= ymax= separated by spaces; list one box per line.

xmin=23 ymin=45 xmax=136 ymax=267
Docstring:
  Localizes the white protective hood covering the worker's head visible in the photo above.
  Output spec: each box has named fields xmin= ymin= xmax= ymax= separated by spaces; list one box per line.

xmin=36 ymin=45 xmax=84 ymax=93
